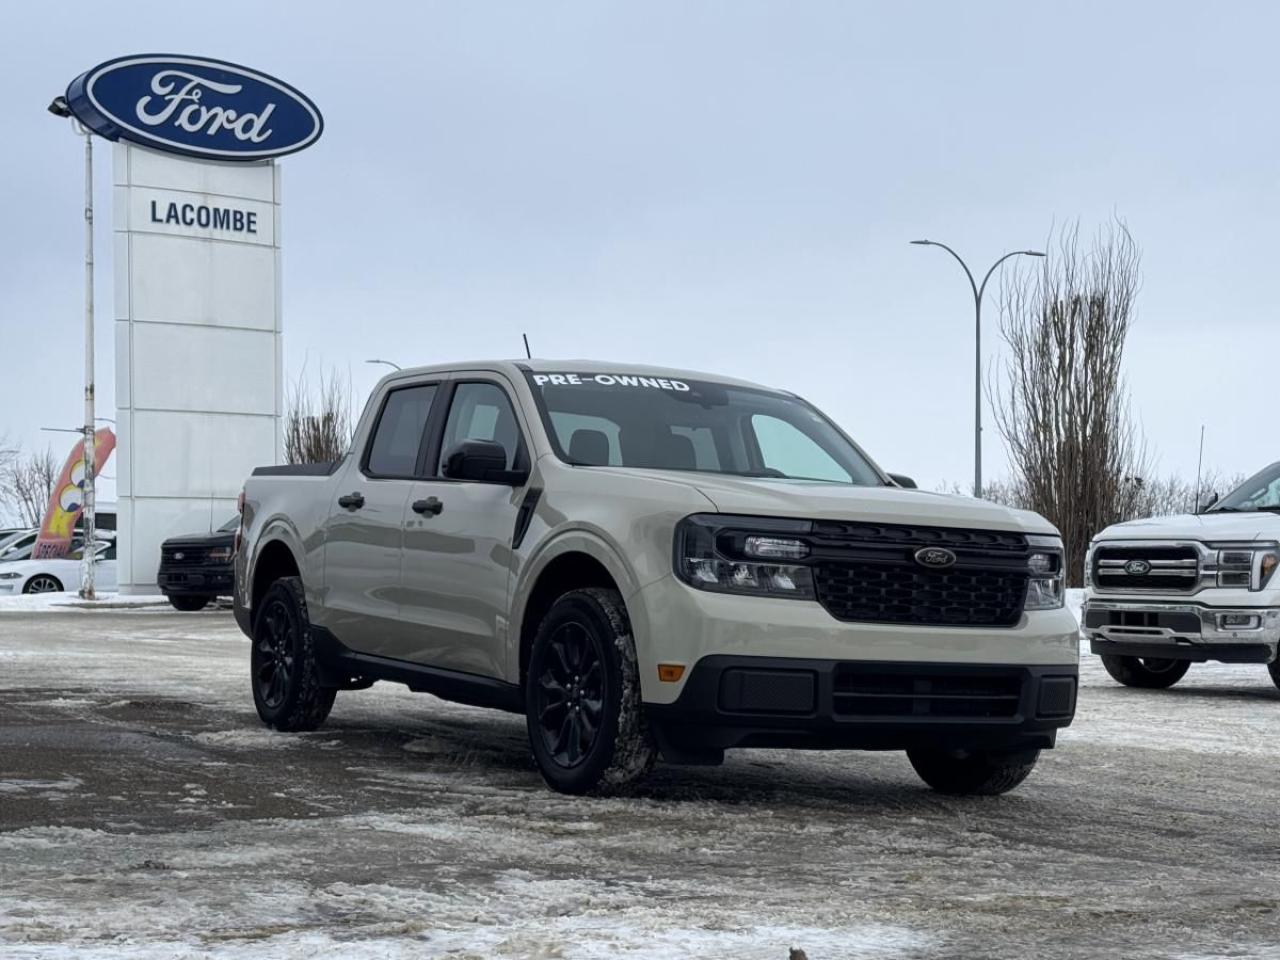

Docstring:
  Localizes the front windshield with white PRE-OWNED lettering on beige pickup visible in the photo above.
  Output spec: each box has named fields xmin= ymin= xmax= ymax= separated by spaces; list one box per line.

xmin=527 ymin=371 xmax=886 ymax=486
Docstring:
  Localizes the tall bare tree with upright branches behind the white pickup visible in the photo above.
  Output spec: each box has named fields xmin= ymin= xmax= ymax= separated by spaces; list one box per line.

xmin=992 ymin=221 xmax=1148 ymax=581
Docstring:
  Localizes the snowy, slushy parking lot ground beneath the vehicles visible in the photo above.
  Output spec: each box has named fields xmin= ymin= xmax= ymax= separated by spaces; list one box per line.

xmin=0 ymin=609 xmax=1280 ymax=960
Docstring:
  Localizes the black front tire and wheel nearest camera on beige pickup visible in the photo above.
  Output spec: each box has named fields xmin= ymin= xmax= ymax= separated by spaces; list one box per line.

xmin=525 ymin=588 xmax=658 ymax=794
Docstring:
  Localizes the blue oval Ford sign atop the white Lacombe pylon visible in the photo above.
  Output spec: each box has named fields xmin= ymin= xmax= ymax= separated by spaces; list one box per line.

xmin=67 ymin=54 xmax=324 ymax=160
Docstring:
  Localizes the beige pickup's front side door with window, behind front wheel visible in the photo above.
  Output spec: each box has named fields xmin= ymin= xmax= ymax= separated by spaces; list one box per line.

xmin=398 ymin=375 xmax=527 ymax=678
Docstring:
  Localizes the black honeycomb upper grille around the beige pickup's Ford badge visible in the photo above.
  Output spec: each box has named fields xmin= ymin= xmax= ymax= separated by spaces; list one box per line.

xmin=813 ymin=522 xmax=1029 ymax=627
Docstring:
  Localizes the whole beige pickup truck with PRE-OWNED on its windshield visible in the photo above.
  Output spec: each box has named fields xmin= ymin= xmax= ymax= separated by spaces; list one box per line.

xmin=236 ymin=361 xmax=1078 ymax=794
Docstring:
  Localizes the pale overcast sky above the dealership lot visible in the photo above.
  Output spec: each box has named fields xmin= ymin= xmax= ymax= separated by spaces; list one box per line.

xmin=0 ymin=0 xmax=1280 ymax=504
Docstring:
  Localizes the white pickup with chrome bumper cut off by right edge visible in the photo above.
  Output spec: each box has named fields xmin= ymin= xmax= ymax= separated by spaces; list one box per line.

xmin=1082 ymin=463 xmax=1280 ymax=687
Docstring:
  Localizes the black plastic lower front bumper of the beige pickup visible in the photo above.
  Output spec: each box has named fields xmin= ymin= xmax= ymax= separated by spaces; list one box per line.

xmin=645 ymin=655 xmax=1078 ymax=763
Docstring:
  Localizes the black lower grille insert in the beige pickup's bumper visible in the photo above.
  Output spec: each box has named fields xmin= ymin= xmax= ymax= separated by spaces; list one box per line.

xmin=832 ymin=664 xmax=1023 ymax=718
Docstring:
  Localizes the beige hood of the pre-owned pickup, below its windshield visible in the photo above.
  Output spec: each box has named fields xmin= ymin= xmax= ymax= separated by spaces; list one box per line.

xmin=602 ymin=467 xmax=1057 ymax=534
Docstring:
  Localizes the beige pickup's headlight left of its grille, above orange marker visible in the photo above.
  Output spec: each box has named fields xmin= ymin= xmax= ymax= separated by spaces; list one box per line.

xmin=675 ymin=513 xmax=817 ymax=600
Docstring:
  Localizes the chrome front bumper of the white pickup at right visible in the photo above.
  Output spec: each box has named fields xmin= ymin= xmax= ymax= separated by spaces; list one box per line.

xmin=1082 ymin=598 xmax=1280 ymax=663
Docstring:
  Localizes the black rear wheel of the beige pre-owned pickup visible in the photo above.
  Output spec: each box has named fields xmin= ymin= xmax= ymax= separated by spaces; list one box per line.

xmin=250 ymin=577 xmax=338 ymax=730
